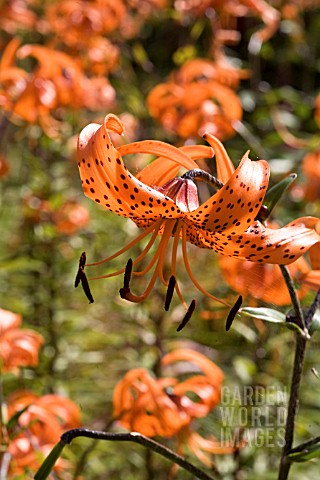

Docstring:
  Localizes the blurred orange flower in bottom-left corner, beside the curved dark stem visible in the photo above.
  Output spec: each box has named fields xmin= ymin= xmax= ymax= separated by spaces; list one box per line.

xmin=7 ymin=391 xmax=80 ymax=475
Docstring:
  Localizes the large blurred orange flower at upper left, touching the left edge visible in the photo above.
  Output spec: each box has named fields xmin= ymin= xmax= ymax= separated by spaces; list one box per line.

xmin=0 ymin=38 xmax=115 ymax=136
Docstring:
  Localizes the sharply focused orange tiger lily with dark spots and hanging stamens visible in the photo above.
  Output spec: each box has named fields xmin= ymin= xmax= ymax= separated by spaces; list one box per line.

xmin=77 ymin=114 xmax=320 ymax=314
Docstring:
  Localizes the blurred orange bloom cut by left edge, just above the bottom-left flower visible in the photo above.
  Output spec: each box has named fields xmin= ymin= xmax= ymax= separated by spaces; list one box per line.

xmin=0 ymin=308 xmax=44 ymax=372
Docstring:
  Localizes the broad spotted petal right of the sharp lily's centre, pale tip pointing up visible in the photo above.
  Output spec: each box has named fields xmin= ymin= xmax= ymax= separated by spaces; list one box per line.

xmin=186 ymin=152 xmax=269 ymax=235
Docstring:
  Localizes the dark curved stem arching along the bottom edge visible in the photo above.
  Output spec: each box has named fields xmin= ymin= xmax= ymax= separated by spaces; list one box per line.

xmin=34 ymin=428 xmax=214 ymax=480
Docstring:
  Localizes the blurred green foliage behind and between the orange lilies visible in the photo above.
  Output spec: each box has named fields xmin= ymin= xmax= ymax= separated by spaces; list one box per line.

xmin=0 ymin=1 xmax=320 ymax=480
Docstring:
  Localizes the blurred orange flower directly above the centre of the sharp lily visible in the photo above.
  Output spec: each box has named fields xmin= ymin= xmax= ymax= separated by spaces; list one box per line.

xmin=147 ymin=59 xmax=249 ymax=140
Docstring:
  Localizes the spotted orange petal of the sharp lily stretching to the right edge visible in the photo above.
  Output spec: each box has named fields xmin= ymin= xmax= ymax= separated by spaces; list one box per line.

xmin=188 ymin=217 xmax=320 ymax=265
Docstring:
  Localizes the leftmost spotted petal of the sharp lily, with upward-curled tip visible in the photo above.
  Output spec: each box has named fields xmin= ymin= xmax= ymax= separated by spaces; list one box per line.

xmin=77 ymin=114 xmax=180 ymax=221
